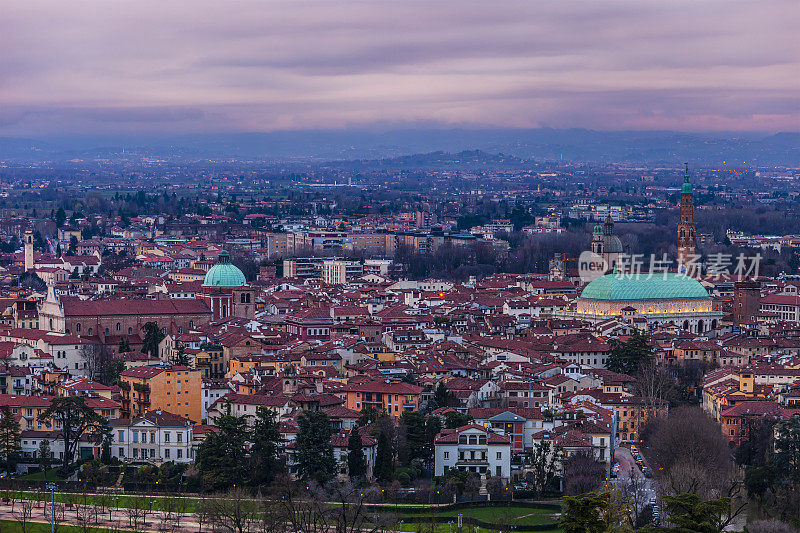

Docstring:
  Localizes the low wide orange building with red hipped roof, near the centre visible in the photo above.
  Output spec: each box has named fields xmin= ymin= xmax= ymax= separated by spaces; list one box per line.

xmin=335 ymin=381 xmax=422 ymax=417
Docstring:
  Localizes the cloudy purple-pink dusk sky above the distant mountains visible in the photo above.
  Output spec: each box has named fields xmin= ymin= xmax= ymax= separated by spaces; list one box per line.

xmin=0 ymin=0 xmax=800 ymax=136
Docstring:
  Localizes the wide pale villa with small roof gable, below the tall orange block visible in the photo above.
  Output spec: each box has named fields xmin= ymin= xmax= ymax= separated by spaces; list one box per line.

xmin=109 ymin=409 xmax=194 ymax=464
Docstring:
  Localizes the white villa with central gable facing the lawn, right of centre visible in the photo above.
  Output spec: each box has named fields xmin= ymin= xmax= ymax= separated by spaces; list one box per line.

xmin=434 ymin=424 xmax=511 ymax=479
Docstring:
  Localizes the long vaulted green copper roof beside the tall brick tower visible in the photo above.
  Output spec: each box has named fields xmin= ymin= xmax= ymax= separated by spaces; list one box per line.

xmin=581 ymin=272 xmax=708 ymax=302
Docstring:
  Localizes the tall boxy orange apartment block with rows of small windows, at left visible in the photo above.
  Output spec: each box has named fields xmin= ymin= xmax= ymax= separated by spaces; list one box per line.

xmin=120 ymin=366 xmax=203 ymax=422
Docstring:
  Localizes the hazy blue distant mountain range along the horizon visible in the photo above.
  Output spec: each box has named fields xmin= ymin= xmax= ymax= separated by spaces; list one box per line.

xmin=0 ymin=129 xmax=800 ymax=167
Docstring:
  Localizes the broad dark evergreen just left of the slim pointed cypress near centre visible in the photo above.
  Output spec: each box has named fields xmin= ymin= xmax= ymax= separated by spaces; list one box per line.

xmin=295 ymin=411 xmax=336 ymax=484
